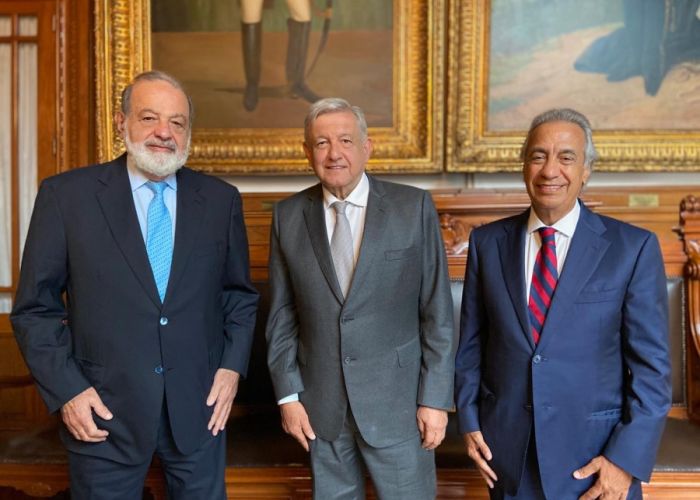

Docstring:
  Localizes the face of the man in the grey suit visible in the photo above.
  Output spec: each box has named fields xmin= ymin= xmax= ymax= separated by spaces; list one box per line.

xmin=304 ymin=111 xmax=372 ymax=200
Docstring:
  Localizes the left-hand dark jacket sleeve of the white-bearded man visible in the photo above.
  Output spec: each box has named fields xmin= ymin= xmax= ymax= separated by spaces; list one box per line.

xmin=10 ymin=182 xmax=90 ymax=413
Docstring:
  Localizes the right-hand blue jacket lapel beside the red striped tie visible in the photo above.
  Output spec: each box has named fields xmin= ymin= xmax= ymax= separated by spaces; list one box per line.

xmin=537 ymin=203 xmax=610 ymax=350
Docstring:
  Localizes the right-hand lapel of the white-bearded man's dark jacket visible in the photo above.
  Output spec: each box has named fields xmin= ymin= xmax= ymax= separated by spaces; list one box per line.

xmin=165 ymin=168 xmax=206 ymax=300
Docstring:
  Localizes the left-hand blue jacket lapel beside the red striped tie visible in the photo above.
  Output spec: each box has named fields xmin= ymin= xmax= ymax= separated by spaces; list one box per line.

xmin=498 ymin=210 xmax=535 ymax=350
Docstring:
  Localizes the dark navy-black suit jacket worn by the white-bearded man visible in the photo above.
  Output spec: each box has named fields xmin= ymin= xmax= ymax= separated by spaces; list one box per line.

xmin=11 ymin=155 xmax=258 ymax=463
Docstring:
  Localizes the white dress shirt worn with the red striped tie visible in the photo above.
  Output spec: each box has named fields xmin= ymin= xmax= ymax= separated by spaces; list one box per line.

xmin=525 ymin=201 xmax=581 ymax=300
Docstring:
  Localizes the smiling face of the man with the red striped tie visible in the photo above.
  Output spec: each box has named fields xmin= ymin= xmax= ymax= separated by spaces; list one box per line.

xmin=523 ymin=121 xmax=591 ymax=225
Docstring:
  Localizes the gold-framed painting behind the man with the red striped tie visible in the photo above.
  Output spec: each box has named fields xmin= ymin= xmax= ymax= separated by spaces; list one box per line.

xmin=446 ymin=0 xmax=700 ymax=172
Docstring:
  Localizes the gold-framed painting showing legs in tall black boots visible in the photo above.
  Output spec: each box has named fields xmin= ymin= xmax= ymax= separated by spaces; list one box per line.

xmin=95 ymin=0 xmax=445 ymax=174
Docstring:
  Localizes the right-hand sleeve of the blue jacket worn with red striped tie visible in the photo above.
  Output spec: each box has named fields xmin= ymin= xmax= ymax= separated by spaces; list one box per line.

xmin=604 ymin=234 xmax=671 ymax=481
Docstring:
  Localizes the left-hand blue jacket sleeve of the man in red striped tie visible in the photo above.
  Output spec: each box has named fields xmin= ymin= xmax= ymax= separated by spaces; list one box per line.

xmin=455 ymin=231 xmax=487 ymax=434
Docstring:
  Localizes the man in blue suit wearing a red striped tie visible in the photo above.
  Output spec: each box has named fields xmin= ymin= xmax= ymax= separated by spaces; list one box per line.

xmin=455 ymin=109 xmax=671 ymax=500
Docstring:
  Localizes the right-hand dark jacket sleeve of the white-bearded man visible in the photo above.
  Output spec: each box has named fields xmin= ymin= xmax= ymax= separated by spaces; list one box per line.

xmin=220 ymin=190 xmax=259 ymax=376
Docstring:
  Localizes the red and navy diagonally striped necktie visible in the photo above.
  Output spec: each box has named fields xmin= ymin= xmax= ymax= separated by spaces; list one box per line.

xmin=528 ymin=227 xmax=559 ymax=344
